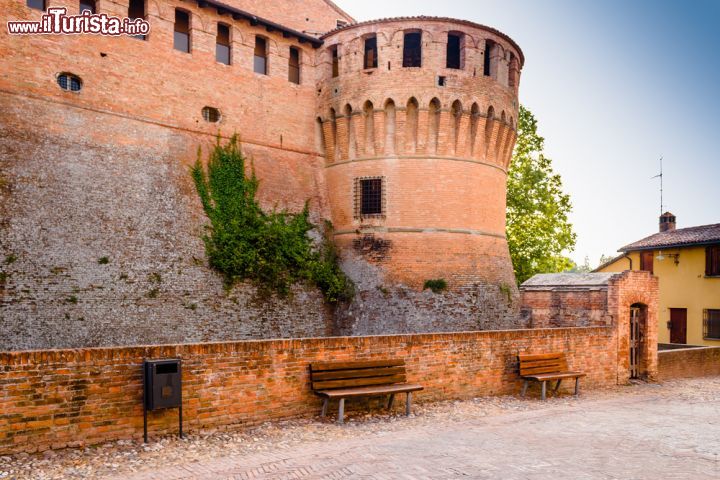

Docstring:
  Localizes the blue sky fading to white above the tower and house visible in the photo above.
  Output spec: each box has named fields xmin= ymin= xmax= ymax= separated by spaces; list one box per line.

xmin=336 ymin=0 xmax=720 ymax=266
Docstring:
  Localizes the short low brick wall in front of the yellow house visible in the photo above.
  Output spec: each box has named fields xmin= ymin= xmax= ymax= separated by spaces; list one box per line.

xmin=658 ymin=347 xmax=720 ymax=381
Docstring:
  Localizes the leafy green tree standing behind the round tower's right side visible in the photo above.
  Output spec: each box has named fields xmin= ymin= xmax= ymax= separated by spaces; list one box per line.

xmin=507 ymin=106 xmax=576 ymax=283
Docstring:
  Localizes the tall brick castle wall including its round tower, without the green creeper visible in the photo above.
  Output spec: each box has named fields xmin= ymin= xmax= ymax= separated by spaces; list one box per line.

xmin=0 ymin=0 xmax=525 ymax=349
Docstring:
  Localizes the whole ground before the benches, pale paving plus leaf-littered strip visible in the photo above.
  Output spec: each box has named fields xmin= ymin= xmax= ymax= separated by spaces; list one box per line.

xmin=0 ymin=377 xmax=720 ymax=480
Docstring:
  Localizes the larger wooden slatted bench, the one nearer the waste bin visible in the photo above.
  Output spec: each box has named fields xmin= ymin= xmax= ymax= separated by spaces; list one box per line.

xmin=310 ymin=360 xmax=423 ymax=423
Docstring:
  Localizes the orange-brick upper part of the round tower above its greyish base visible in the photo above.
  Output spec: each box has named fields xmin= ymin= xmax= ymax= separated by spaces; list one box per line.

xmin=318 ymin=17 xmax=524 ymax=290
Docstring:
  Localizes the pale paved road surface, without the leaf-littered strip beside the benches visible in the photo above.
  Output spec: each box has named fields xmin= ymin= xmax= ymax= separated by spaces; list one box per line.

xmin=107 ymin=381 xmax=720 ymax=480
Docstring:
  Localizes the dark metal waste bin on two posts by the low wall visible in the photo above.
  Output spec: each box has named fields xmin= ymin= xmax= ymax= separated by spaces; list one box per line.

xmin=143 ymin=359 xmax=183 ymax=443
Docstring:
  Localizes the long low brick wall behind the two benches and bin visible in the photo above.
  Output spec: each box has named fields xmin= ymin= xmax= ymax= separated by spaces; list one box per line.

xmin=0 ymin=327 xmax=618 ymax=454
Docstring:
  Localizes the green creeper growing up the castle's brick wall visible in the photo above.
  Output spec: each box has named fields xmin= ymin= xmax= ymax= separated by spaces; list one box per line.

xmin=191 ymin=136 xmax=352 ymax=303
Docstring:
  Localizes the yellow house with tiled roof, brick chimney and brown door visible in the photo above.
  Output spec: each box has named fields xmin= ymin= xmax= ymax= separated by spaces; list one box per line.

xmin=595 ymin=213 xmax=720 ymax=346
